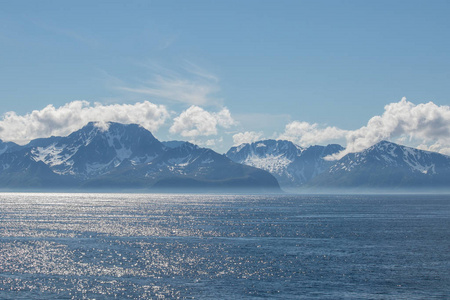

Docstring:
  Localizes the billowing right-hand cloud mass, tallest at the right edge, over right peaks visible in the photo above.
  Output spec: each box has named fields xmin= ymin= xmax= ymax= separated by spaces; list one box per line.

xmin=278 ymin=98 xmax=450 ymax=160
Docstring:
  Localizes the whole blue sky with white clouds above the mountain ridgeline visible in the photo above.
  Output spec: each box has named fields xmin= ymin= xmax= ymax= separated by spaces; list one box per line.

xmin=0 ymin=0 xmax=450 ymax=158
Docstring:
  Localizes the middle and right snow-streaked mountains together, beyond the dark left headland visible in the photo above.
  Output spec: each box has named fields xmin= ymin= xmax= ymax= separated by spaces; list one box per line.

xmin=227 ymin=140 xmax=450 ymax=190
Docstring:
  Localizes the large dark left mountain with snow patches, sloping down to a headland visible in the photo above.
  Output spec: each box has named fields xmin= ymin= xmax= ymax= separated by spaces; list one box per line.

xmin=0 ymin=122 xmax=279 ymax=190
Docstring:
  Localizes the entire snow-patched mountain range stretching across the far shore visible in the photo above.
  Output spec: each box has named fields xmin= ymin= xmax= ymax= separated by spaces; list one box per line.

xmin=0 ymin=122 xmax=450 ymax=192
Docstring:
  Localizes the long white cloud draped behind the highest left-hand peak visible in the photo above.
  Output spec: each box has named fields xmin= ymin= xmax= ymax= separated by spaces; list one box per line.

xmin=0 ymin=101 xmax=169 ymax=144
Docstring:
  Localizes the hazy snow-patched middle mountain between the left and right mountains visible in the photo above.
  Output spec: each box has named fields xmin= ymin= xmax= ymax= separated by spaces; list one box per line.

xmin=227 ymin=140 xmax=343 ymax=187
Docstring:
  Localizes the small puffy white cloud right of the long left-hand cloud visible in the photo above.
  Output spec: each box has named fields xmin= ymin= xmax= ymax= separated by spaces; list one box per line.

xmin=170 ymin=105 xmax=236 ymax=137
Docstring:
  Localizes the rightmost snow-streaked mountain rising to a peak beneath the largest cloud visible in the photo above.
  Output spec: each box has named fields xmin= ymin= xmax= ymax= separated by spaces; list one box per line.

xmin=309 ymin=141 xmax=450 ymax=187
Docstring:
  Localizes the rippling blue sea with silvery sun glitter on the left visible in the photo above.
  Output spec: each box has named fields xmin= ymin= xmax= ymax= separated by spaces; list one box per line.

xmin=0 ymin=193 xmax=450 ymax=299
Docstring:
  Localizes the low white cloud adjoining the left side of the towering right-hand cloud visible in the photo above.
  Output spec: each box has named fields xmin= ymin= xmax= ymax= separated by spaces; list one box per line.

xmin=278 ymin=121 xmax=348 ymax=147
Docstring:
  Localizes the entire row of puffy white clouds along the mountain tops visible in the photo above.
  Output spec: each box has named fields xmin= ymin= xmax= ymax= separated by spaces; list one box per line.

xmin=0 ymin=98 xmax=450 ymax=160
